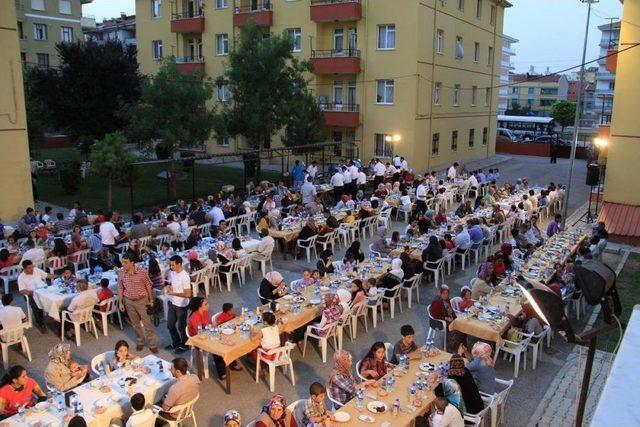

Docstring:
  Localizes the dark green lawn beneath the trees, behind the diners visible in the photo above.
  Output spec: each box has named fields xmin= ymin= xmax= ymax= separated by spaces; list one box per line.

xmin=37 ymin=148 xmax=280 ymax=213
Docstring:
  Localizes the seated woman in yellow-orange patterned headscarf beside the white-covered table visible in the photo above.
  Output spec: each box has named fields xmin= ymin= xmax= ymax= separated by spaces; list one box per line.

xmin=44 ymin=343 xmax=89 ymax=392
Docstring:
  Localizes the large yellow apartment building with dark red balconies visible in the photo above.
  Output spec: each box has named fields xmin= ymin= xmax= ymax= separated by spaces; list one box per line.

xmin=136 ymin=0 xmax=511 ymax=169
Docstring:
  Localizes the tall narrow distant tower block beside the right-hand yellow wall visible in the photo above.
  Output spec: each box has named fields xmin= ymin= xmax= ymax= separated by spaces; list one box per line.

xmin=595 ymin=21 xmax=620 ymax=124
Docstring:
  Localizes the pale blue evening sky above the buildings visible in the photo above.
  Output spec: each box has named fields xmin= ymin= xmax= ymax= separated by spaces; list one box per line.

xmin=82 ymin=0 xmax=622 ymax=72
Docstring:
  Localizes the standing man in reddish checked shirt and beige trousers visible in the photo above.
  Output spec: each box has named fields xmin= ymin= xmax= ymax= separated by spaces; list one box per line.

xmin=118 ymin=253 xmax=158 ymax=354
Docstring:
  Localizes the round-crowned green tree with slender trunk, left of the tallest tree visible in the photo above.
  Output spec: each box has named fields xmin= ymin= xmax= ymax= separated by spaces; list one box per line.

xmin=123 ymin=58 xmax=214 ymax=197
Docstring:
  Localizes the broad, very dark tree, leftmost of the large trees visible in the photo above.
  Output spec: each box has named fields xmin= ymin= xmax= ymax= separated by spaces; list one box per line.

xmin=30 ymin=41 xmax=140 ymax=139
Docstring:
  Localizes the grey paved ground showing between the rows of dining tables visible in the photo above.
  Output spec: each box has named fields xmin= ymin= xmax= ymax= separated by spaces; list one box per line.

xmin=9 ymin=156 xmax=617 ymax=426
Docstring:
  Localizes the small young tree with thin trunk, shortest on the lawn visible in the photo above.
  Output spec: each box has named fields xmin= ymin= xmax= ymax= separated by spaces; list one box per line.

xmin=91 ymin=131 xmax=135 ymax=210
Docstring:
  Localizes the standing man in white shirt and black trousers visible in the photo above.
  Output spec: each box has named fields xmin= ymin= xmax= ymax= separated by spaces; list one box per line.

xmin=165 ymin=255 xmax=191 ymax=354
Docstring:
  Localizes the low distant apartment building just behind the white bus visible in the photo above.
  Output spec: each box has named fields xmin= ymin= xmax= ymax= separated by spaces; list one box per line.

xmin=511 ymin=74 xmax=569 ymax=117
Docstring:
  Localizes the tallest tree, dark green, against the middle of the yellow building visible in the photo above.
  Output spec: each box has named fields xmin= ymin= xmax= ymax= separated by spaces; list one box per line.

xmin=215 ymin=24 xmax=319 ymax=181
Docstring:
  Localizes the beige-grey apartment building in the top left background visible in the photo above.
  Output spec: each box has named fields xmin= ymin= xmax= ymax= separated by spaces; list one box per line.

xmin=15 ymin=0 xmax=95 ymax=68
